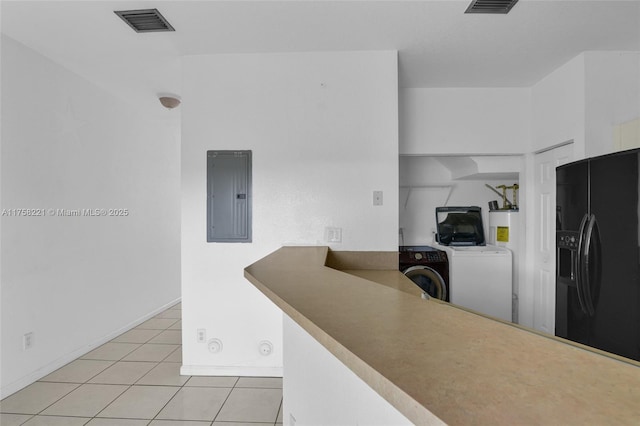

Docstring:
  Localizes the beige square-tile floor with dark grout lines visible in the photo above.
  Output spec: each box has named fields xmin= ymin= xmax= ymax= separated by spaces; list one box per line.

xmin=0 ymin=304 xmax=282 ymax=426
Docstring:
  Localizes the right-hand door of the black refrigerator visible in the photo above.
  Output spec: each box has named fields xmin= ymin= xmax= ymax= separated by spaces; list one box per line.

xmin=588 ymin=151 xmax=640 ymax=360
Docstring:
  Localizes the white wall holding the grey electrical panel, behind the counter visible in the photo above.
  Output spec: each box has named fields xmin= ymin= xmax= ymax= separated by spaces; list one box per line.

xmin=182 ymin=51 xmax=398 ymax=375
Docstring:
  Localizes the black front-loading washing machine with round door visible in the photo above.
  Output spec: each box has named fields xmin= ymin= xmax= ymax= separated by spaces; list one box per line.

xmin=399 ymin=246 xmax=450 ymax=302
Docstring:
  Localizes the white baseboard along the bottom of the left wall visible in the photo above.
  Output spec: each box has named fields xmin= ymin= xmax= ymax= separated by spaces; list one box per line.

xmin=0 ymin=297 xmax=182 ymax=399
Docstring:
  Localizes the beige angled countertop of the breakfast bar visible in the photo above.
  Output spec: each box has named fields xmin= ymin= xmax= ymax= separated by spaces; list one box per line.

xmin=245 ymin=247 xmax=640 ymax=425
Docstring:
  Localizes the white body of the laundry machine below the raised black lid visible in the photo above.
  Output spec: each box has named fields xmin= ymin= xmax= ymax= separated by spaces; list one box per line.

xmin=433 ymin=243 xmax=512 ymax=321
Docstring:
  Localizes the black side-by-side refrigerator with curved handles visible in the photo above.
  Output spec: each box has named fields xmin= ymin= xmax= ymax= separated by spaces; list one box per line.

xmin=555 ymin=150 xmax=640 ymax=361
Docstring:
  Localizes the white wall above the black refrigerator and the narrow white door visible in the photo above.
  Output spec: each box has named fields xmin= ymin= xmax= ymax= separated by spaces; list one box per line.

xmin=531 ymin=52 xmax=640 ymax=159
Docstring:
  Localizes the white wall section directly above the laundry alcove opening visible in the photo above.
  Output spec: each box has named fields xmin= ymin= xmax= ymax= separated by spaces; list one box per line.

xmin=400 ymin=88 xmax=531 ymax=155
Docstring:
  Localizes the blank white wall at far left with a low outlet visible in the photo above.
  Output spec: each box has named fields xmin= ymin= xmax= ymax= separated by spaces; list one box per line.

xmin=1 ymin=36 xmax=180 ymax=397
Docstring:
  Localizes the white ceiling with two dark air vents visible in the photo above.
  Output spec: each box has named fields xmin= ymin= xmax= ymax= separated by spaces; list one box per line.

xmin=0 ymin=0 xmax=640 ymax=114
